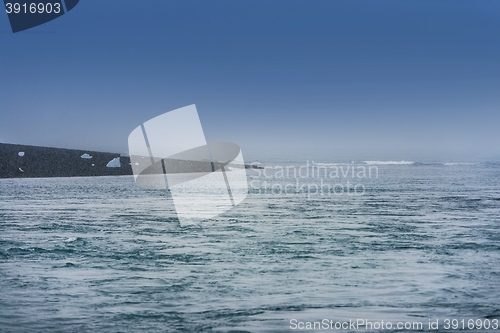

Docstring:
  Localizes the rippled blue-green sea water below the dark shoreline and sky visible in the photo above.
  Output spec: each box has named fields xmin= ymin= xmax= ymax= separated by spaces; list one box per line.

xmin=0 ymin=161 xmax=500 ymax=332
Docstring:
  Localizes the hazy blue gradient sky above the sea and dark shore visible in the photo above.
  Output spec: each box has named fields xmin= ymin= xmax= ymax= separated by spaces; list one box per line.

xmin=0 ymin=0 xmax=500 ymax=160
